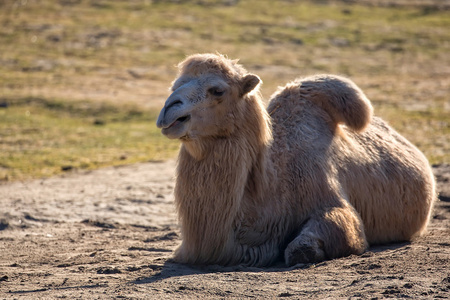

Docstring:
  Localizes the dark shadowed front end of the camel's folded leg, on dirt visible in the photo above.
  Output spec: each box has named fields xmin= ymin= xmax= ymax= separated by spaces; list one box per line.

xmin=284 ymin=237 xmax=326 ymax=266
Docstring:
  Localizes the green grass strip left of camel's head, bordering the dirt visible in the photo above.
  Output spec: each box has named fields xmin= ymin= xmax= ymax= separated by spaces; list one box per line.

xmin=0 ymin=98 xmax=179 ymax=181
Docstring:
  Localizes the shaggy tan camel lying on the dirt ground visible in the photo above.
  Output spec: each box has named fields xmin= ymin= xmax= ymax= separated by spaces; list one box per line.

xmin=157 ymin=54 xmax=436 ymax=267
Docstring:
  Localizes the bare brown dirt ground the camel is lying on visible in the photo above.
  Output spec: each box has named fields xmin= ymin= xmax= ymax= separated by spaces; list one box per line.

xmin=0 ymin=161 xmax=450 ymax=299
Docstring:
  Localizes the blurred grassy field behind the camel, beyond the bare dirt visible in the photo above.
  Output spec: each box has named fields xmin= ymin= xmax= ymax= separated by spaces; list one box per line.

xmin=0 ymin=0 xmax=450 ymax=183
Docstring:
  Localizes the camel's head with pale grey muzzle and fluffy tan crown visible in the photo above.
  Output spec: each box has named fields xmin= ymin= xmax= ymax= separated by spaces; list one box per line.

xmin=156 ymin=54 xmax=260 ymax=140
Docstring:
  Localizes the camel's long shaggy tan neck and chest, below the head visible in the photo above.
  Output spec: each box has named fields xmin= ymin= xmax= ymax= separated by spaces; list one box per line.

xmin=175 ymin=95 xmax=270 ymax=264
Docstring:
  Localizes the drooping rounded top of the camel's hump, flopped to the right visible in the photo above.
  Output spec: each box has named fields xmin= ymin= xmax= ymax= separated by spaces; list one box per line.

xmin=300 ymin=75 xmax=373 ymax=131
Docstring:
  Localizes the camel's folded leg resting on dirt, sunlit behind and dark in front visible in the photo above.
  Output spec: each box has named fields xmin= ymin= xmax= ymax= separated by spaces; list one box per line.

xmin=284 ymin=205 xmax=367 ymax=266
